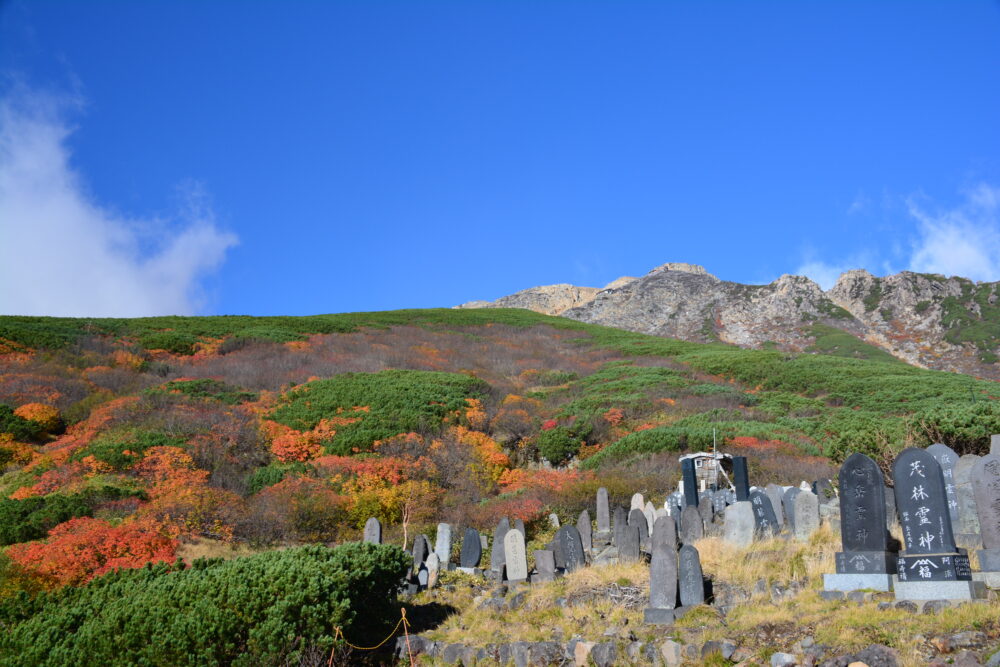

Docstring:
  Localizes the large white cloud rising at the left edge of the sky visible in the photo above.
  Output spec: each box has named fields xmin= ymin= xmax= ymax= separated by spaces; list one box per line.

xmin=0 ymin=88 xmax=237 ymax=317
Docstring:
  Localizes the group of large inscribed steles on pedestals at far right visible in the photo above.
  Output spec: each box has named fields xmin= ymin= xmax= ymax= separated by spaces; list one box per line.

xmin=824 ymin=435 xmax=1000 ymax=600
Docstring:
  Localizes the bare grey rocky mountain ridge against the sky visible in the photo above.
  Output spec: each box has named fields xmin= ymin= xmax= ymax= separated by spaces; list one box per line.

xmin=460 ymin=264 xmax=1000 ymax=379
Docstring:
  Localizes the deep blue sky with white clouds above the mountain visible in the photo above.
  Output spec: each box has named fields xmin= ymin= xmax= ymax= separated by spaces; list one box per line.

xmin=0 ymin=0 xmax=1000 ymax=315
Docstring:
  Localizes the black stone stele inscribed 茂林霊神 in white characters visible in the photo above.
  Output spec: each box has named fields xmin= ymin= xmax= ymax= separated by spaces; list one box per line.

xmin=892 ymin=447 xmax=972 ymax=581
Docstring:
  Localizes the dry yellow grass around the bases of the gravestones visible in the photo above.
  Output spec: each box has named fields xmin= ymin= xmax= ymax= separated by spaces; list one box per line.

xmin=406 ymin=524 xmax=1000 ymax=665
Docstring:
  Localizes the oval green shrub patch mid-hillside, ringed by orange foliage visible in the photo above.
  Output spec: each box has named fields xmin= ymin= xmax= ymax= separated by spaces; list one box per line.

xmin=271 ymin=370 xmax=489 ymax=455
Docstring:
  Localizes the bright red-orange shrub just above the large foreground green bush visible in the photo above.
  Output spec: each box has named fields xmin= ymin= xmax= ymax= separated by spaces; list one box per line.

xmin=7 ymin=517 xmax=177 ymax=586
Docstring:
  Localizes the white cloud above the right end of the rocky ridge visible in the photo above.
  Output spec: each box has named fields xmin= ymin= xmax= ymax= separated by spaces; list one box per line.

xmin=907 ymin=184 xmax=1000 ymax=280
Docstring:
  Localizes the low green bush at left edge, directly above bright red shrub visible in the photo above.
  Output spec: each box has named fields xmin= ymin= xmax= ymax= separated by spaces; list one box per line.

xmin=0 ymin=486 xmax=141 ymax=546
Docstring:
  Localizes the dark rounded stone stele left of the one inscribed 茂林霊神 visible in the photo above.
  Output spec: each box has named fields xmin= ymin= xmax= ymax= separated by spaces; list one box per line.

xmin=837 ymin=452 xmax=896 ymax=574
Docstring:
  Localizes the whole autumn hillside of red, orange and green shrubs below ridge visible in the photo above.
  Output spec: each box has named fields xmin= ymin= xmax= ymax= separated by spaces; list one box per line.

xmin=0 ymin=309 xmax=1000 ymax=662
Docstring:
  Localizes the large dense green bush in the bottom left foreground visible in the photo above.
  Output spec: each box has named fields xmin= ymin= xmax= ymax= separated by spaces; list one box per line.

xmin=0 ymin=543 xmax=410 ymax=666
